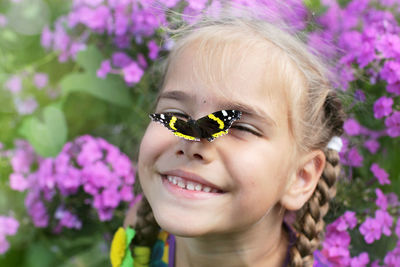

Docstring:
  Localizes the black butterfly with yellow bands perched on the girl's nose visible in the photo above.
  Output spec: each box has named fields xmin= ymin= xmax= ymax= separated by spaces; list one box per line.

xmin=150 ymin=110 xmax=242 ymax=142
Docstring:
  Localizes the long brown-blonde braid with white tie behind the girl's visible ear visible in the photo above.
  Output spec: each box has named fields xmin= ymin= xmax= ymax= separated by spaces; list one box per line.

xmin=290 ymin=92 xmax=345 ymax=267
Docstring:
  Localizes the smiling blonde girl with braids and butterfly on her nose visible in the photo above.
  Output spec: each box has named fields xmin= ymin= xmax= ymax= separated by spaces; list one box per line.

xmin=111 ymin=6 xmax=343 ymax=267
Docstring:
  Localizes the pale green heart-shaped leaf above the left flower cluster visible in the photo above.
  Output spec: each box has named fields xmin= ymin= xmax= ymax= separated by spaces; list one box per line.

xmin=19 ymin=106 xmax=67 ymax=157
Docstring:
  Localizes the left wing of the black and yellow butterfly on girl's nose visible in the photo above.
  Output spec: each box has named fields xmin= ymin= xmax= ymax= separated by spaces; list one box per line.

xmin=150 ymin=113 xmax=200 ymax=141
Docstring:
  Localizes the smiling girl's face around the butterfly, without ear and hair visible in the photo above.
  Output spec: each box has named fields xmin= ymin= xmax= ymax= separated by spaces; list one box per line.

xmin=139 ymin=40 xmax=295 ymax=236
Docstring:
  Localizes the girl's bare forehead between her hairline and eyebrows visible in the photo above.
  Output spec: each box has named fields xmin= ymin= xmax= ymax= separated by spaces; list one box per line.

xmin=163 ymin=37 xmax=286 ymax=116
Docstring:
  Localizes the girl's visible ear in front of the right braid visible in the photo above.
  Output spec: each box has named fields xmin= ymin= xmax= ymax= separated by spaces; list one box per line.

xmin=280 ymin=150 xmax=325 ymax=210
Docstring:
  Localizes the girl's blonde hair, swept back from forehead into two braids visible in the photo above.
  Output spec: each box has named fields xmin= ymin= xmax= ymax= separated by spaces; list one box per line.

xmin=135 ymin=6 xmax=344 ymax=266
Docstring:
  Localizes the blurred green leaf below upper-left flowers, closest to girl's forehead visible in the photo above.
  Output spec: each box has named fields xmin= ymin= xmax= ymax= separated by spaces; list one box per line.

xmin=60 ymin=46 xmax=133 ymax=107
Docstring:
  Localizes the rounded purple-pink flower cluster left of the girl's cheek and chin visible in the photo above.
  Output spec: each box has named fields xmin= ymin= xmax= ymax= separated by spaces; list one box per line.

xmin=10 ymin=135 xmax=135 ymax=232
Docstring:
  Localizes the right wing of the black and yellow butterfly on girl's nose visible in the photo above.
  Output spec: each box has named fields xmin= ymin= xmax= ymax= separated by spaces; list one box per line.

xmin=196 ymin=110 xmax=242 ymax=142
